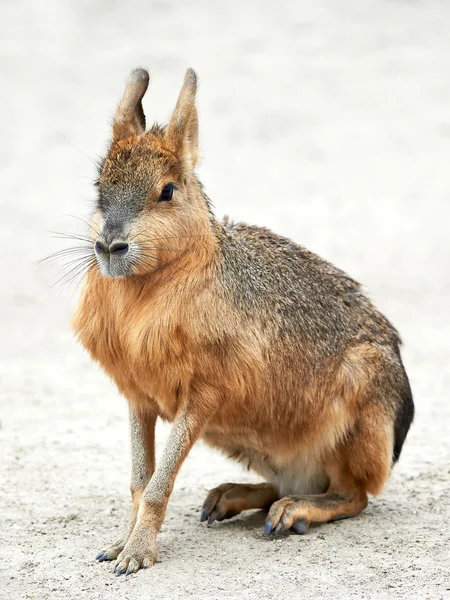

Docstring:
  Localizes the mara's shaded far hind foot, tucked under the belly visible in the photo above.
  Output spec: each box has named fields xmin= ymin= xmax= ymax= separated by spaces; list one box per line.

xmin=200 ymin=483 xmax=279 ymax=524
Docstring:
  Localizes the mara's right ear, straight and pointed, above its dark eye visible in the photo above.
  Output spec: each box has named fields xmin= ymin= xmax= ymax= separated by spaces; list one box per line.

xmin=166 ymin=69 xmax=198 ymax=169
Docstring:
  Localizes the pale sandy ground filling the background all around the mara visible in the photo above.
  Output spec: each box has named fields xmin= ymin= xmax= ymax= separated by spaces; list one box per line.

xmin=0 ymin=0 xmax=450 ymax=600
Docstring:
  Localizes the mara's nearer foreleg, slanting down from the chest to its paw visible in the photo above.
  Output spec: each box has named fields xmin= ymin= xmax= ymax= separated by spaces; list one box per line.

xmin=115 ymin=390 xmax=216 ymax=575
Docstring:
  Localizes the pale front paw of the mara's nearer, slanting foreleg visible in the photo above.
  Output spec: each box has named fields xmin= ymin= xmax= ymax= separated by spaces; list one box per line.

xmin=114 ymin=524 xmax=156 ymax=576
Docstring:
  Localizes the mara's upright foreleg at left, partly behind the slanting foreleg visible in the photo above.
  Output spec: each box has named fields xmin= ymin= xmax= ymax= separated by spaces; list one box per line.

xmin=96 ymin=405 xmax=157 ymax=562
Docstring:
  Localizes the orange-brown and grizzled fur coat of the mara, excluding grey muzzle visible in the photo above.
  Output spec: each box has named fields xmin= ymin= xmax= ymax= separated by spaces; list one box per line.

xmin=73 ymin=71 xmax=412 ymax=574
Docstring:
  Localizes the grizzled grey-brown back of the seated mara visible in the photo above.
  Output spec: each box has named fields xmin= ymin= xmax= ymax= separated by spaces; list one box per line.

xmin=220 ymin=222 xmax=400 ymax=360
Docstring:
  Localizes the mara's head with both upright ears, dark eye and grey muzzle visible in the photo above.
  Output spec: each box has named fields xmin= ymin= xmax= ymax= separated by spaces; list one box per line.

xmin=92 ymin=69 xmax=211 ymax=278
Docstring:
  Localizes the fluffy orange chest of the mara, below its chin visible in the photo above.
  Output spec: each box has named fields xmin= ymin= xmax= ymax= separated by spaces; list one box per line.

xmin=72 ymin=281 xmax=195 ymax=419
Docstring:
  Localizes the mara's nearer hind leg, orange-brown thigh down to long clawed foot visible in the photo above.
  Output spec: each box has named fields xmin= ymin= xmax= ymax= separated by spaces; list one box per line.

xmin=264 ymin=403 xmax=393 ymax=535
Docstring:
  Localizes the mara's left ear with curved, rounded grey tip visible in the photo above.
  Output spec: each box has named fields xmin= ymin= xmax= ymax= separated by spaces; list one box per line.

xmin=113 ymin=69 xmax=150 ymax=142
